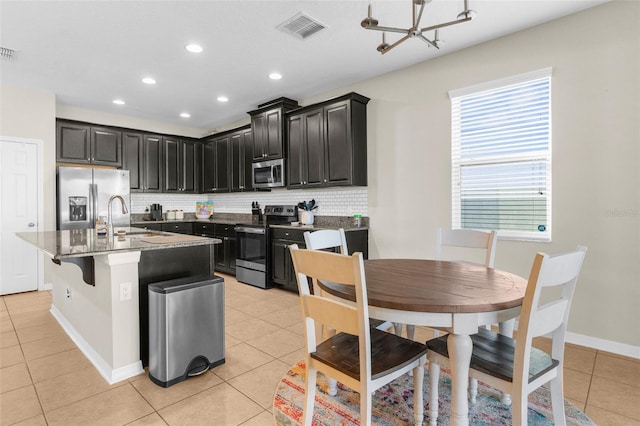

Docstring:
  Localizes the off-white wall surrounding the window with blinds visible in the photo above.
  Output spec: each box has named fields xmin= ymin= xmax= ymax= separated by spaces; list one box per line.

xmin=305 ymin=1 xmax=640 ymax=356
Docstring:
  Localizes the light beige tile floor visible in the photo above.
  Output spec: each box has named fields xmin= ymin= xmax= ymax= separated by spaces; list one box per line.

xmin=0 ymin=276 xmax=640 ymax=426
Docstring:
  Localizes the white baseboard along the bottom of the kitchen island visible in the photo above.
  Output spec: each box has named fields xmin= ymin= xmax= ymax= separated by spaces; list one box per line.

xmin=50 ymin=305 xmax=144 ymax=385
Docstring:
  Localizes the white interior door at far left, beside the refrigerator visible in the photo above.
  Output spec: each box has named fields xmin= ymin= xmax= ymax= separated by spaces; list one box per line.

xmin=0 ymin=139 xmax=39 ymax=294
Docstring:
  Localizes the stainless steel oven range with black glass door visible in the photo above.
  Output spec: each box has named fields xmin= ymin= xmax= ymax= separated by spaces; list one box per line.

xmin=235 ymin=205 xmax=298 ymax=288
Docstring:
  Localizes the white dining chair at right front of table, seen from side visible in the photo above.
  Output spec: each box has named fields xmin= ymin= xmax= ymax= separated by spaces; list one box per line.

xmin=427 ymin=246 xmax=587 ymax=426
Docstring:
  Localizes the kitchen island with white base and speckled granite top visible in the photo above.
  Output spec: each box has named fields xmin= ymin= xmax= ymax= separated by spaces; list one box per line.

xmin=17 ymin=227 xmax=221 ymax=384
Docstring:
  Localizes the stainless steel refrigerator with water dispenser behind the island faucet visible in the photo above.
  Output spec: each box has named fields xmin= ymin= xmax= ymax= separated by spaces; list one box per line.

xmin=57 ymin=167 xmax=131 ymax=230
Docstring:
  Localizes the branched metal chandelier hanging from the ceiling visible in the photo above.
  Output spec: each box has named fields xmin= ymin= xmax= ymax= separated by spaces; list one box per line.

xmin=360 ymin=0 xmax=476 ymax=55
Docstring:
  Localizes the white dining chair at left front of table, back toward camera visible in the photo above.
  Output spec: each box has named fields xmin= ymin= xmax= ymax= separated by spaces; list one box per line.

xmin=290 ymin=244 xmax=426 ymax=425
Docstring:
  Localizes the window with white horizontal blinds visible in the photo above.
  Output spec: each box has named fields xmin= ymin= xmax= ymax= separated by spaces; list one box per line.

xmin=449 ymin=68 xmax=551 ymax=241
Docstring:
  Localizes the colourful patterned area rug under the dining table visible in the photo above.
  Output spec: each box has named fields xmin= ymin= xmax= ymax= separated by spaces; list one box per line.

xmin=273 ymin=361 xmax=595 ymax=426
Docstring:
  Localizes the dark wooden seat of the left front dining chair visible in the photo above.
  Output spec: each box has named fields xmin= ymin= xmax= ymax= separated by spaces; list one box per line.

xmin=310 ymin=327 xmax=427 ymax=380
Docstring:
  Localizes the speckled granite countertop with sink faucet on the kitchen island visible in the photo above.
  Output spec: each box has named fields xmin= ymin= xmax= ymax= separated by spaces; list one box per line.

xmin=16 ymin=227 xmax=222 ymax=259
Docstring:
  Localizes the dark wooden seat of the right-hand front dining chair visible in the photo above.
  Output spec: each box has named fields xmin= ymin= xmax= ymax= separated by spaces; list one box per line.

xmin=427 ymin=328 xmax=560 ymax=383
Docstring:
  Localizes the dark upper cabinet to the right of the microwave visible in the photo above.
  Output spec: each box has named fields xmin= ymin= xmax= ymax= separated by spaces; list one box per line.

xmin=286 ymin=93 xmax=369 ymax=188
